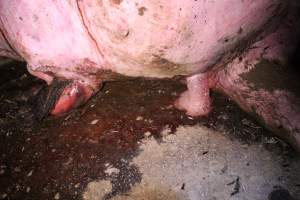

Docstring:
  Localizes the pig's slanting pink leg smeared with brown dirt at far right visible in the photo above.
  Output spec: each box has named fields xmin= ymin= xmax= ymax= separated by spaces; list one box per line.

xmin=216 ymin=3 xmax=300 ymax=151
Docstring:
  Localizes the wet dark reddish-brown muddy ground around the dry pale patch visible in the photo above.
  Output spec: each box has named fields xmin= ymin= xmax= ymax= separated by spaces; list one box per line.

xmin=0 ymin=61 xmax=300 ymax=199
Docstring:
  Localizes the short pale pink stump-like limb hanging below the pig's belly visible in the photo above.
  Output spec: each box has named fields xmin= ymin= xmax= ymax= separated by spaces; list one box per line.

xmin=175 ymin=74 xmax=211 ymax=116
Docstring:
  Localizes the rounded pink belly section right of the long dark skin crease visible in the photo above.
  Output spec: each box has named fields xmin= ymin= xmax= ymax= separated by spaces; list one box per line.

xmin=78 ymin=0 xmax=284 ymax=78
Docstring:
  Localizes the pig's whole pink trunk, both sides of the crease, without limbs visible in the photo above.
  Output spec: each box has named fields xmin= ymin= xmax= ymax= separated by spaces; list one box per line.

xmin=0 ymin=0 xmax=287 ymax=80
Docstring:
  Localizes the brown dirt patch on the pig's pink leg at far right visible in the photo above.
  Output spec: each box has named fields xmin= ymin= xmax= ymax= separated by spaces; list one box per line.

xmin=240 ymin=59 xmax=300 ymax=97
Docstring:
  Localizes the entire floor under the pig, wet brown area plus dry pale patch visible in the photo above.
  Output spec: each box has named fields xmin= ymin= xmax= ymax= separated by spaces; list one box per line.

xmin=0 ymin=59 xmax=300 ymax=200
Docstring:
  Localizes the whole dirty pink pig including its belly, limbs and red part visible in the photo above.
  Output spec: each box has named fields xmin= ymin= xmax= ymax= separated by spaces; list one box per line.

xmin=0 ymin=0 xmax=300 ymax=152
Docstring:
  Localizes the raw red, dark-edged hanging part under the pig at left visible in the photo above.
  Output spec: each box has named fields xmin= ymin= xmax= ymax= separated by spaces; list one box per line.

xmin=36 ymin=80 xmax=94 ymax=120
